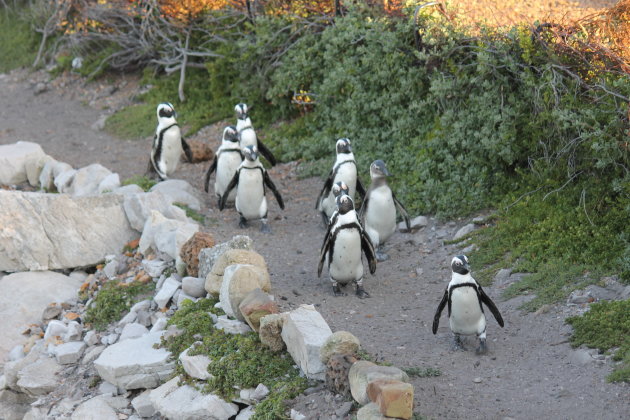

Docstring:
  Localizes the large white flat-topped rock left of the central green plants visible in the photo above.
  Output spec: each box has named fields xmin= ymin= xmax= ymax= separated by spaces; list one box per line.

xmin=94 ymin=333 xmax=175 ymax=390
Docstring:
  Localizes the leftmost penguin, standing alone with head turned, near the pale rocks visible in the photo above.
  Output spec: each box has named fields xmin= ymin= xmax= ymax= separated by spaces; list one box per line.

xmin=149 ymin=102 xmax=192 ymax=180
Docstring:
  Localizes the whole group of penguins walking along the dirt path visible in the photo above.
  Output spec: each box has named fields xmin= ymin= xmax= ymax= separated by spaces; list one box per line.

xmin=149 ymin=102 xmax=504 ymax=354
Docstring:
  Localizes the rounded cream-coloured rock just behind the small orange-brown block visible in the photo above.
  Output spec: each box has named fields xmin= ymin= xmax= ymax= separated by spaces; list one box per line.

xmin=219 ymin=264 xmax=277 ymax=321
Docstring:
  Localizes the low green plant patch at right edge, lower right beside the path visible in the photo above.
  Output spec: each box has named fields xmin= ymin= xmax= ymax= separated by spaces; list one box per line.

xmin=566 ymin=299 xmax=630 ymax=382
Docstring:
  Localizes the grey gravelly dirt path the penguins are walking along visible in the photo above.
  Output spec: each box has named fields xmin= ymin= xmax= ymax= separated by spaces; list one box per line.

xmin=0 ymin=31 xmax=630 ymax=419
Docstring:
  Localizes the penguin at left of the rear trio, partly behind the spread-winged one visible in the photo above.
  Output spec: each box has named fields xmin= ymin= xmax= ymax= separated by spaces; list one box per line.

xmin=204 ymin=125 xmax=243 ymax=203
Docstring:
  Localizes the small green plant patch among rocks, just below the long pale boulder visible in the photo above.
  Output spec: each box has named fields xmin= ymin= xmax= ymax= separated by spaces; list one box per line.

xmin=84 ymin=281 xmax=155 ymax=331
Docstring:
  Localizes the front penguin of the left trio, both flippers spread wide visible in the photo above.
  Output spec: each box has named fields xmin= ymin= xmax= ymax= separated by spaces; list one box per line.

xmin=219 ymin=146 xmax=284 ymax=233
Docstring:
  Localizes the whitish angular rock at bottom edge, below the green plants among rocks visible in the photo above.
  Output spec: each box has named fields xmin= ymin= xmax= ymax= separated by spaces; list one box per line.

xmin=150 ymin=377 xmax=238 ymax=420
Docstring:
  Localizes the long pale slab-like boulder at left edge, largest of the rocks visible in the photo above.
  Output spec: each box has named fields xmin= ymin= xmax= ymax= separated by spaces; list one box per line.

xmin=0 ymin=191 xmax=136 ymax=272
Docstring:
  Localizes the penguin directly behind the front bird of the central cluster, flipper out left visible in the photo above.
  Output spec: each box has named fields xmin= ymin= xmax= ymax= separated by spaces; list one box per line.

xmin=315 ymin=138 xmax=365 ymax=226
